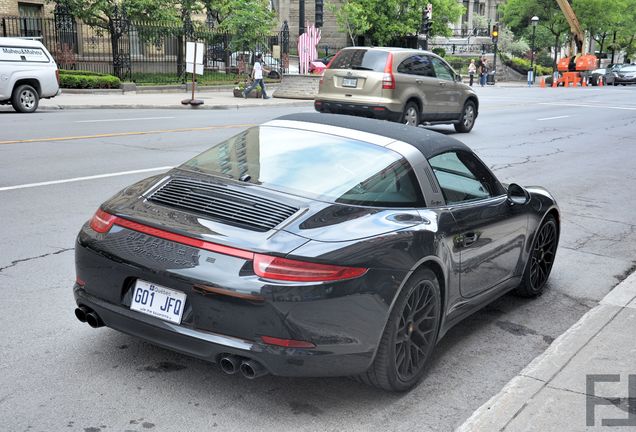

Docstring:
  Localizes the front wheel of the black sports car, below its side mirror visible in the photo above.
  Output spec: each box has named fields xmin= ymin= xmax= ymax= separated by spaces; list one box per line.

xmin=514 ymin=215 xmax=559 ymax=298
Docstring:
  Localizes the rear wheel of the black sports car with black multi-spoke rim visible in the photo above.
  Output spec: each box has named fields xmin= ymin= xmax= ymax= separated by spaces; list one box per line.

xmin=357 ymin=268 xmax=442 ymax=392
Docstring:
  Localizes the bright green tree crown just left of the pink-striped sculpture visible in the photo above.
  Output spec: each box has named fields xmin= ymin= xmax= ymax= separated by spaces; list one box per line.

xmin=217 ymin=0 xmax=276 ymax=50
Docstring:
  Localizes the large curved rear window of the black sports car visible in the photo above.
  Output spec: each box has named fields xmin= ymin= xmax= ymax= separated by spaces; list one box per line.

xmin=181 ymin=126 xmax=424 ymax=207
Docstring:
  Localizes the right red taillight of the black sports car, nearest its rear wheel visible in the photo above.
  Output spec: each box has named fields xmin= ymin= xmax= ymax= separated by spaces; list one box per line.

xmin=254 ymin=254 xmax=368 ymax=282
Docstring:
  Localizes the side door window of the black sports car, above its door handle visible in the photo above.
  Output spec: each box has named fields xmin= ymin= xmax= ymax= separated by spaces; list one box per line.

xmin=428 ymin=151 xmax=499 ymax=204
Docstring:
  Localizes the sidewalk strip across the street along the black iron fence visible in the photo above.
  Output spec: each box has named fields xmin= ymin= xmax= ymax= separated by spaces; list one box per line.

xmin=39 ymin=89 xmax=313 ymax=110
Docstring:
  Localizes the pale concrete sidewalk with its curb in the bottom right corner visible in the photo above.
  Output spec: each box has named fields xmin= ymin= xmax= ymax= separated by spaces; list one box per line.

xmin=457 ymin=273 xmax=636 ymax=432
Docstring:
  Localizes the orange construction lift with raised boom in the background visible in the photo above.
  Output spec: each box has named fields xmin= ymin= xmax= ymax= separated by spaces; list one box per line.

xmin=556 ymin=0 xmax=598 ymax=86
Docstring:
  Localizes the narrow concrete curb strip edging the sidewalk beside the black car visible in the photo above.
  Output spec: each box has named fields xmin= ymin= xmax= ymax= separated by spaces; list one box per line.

xmin=455 ymin=272 xmax=636 ymax=432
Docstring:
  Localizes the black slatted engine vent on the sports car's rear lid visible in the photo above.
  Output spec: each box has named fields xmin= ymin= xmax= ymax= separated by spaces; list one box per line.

xmin=148 ymin=178 xmax=298 ymax=231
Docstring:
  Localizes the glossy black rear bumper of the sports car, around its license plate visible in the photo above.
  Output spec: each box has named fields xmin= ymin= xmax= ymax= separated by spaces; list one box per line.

xmin=73 ymin=230 xmax=407 ymax=377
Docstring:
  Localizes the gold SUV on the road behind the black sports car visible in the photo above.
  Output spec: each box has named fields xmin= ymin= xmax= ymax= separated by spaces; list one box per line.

xmin=314 ymin=47 xmax=479 ymax=132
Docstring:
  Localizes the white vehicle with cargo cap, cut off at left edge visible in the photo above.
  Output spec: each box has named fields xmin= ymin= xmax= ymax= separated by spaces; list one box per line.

xmin=0 ymin=37 xmax=60 ymax=113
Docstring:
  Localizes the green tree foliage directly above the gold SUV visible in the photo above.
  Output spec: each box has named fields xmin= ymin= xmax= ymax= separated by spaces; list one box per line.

xmin=328 ymin=0 xmax=464 ymax=45
